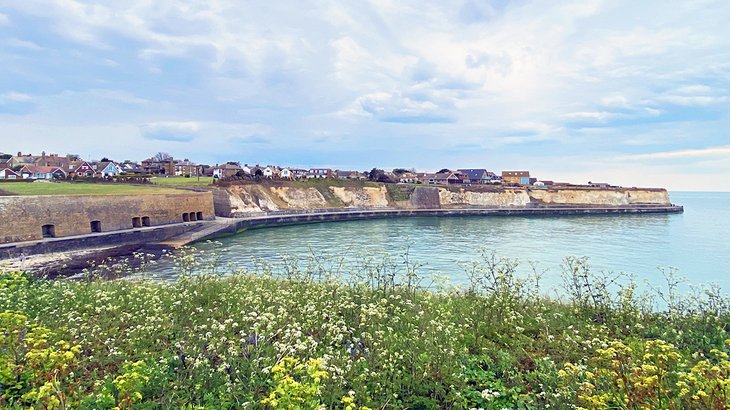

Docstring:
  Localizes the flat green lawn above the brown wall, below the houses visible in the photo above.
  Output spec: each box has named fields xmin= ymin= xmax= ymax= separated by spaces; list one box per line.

xmin=0 ymin=182 xmax=180 ymax=195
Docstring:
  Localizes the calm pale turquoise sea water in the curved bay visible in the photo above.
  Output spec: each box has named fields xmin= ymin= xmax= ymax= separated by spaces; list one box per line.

xmin=142 ymin=192 xmax=730 ymax=293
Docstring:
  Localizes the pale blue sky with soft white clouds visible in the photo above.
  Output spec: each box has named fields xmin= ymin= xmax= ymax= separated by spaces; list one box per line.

xmin=0 ymin=0 xmax=730 ymax=191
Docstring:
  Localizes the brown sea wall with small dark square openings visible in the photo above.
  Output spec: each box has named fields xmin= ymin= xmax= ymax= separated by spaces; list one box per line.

xmin=0 ymin=192 xmax=215 ymax=243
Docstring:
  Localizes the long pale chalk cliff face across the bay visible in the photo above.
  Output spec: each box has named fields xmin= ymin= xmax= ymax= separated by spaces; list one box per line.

xmin=214 ymin=185 xmax=671 ymax=216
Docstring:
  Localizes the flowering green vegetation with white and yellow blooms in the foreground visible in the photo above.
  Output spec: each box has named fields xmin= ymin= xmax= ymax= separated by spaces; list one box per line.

xmin=0 ymin=250 xmax=730 ymax=409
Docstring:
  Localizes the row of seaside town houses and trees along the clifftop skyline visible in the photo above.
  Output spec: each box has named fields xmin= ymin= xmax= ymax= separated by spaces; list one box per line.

xmin=0 ymin=151 xmax=611 ymax=188
